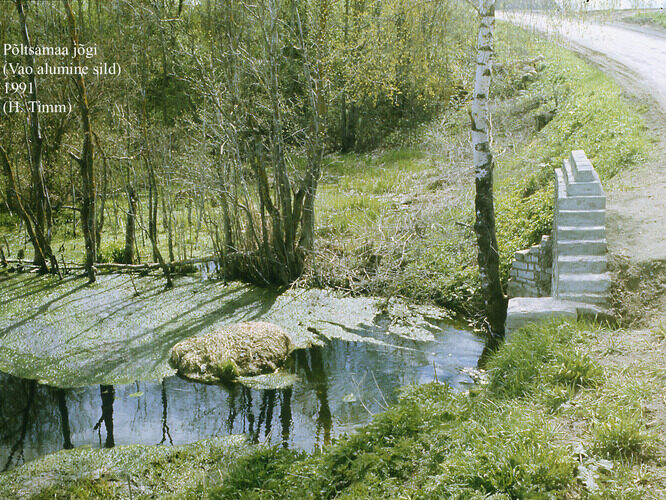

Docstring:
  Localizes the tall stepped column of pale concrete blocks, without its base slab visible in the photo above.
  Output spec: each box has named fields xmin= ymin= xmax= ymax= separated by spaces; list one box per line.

xmin=552 ymin=151 xmax=610 ymax=307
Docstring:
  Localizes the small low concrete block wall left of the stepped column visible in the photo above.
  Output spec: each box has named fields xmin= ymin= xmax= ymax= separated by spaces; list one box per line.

xmin=507 ymin=236 xmax=553 ymax=297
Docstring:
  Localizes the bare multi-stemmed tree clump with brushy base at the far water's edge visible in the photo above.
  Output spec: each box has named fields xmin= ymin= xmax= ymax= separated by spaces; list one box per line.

xmin=183 ymin=0 xmax=331 ymax=284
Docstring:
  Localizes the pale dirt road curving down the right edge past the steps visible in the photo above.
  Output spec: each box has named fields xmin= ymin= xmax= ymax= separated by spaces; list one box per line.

xmin=497 ymin=12 xmax=666 ymax=282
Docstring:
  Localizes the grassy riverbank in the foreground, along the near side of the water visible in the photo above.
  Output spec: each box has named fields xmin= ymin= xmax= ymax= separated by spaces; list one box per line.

xmin=0 ymin=323 xmax=666 ymax=500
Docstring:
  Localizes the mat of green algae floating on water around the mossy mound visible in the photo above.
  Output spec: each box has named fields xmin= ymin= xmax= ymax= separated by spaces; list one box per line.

xmin=0 ymin=273 xmax=466 ymax=387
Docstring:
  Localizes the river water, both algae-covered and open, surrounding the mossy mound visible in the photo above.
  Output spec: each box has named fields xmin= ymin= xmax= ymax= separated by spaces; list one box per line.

xmin=0 ymin=273 xmax=484 ymax=470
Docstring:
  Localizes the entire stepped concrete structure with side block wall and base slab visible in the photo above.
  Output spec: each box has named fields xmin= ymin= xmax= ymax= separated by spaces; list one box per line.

xmin=506 ymin=151 xmax=611 ymax=333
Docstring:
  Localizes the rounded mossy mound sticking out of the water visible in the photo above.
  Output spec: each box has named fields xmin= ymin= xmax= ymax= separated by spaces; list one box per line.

xmin=171 ymin=321 xmax=293 ymax=382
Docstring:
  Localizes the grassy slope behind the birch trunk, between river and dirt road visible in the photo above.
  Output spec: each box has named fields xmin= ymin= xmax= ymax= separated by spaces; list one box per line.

xmin=308 ymin=21 xmax=648 ymax=313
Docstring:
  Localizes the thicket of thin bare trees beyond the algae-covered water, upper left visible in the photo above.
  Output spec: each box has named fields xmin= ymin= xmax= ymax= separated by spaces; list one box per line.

xmin=0 ymin=0 xmax=476 ymax=284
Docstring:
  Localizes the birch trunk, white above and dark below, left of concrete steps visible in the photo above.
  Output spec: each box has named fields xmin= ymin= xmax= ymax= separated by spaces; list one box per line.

xmin=470 ymin=0 xmax=507 ymax=337
